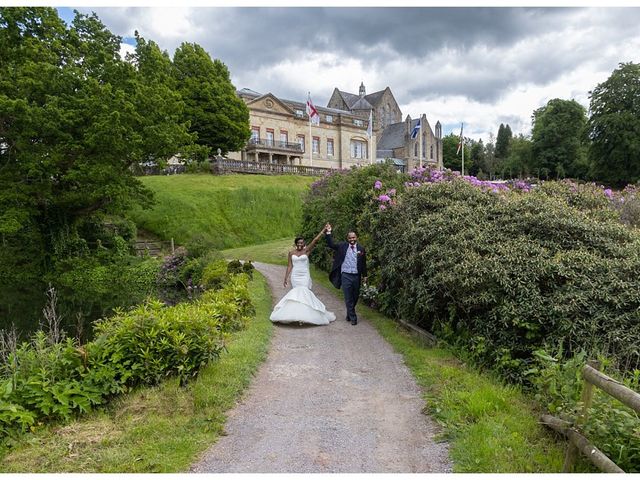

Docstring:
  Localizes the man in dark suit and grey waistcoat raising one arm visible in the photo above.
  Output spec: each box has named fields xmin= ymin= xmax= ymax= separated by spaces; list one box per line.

xmin=325 ymin=223 xmax=367 ymax=325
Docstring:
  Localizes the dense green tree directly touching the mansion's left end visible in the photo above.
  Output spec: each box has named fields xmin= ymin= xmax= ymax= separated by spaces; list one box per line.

xmin=173 ymin=43 xmax=251 ymax=154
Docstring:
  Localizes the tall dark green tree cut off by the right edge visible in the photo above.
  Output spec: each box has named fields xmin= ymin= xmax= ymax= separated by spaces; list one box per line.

xmin=587 ymin=63 xmax=640 ymax=186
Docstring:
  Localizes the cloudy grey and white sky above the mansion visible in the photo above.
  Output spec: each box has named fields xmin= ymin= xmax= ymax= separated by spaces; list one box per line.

xmin=59 ymin=6 xmax=640 ymax=141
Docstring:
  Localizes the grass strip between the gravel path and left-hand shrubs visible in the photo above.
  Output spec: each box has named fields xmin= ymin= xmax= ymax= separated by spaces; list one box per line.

xmin=0 ymin=272 xmax=273 ymax=473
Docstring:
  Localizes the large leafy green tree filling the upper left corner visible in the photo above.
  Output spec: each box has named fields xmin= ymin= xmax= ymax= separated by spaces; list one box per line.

xmin=0 ymin=7 xmax=191 ymax=328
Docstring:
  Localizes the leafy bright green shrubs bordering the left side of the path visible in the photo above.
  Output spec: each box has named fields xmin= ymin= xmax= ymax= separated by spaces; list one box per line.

xmin=0 ymin=268 xmax=254 ymax=444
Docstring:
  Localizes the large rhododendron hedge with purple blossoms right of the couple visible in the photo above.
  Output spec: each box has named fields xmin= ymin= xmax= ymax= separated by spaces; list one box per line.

xmin=305 ymin=164 xmax=640 ymax=382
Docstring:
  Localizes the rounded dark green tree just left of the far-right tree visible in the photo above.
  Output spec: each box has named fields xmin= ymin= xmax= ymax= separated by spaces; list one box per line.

xmin=531 ymin=98 xmax=588 ymax=179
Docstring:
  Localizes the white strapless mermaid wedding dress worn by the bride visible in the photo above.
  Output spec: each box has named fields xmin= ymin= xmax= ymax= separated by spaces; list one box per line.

xmin=270 ymin=254 xmax=336 ymax=325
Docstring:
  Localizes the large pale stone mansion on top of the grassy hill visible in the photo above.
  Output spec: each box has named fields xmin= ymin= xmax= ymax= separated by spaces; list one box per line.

xmin=228 ymin=84 xmax=442 ymax=171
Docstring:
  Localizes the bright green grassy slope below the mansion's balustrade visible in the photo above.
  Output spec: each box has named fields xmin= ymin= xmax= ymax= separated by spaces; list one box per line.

xmin=131 ymin=174 xmax=313 ymax=250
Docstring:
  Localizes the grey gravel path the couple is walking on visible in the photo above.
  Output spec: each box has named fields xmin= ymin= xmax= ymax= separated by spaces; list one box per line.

xmin=191 ymin=263 xmax=451 ymax=473
